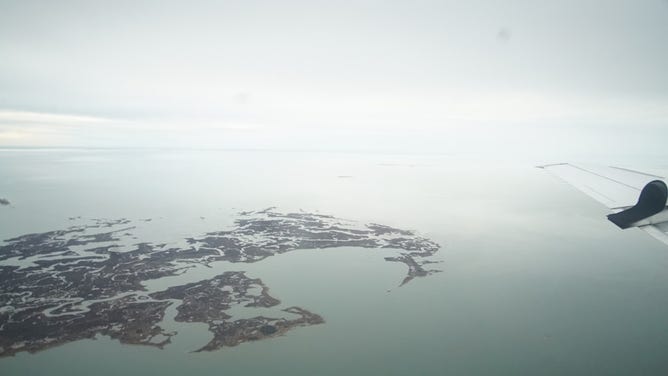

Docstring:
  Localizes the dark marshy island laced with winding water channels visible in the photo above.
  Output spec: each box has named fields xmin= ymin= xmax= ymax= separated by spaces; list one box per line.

xmin=0 ymin=208 xmax=440 ymax=357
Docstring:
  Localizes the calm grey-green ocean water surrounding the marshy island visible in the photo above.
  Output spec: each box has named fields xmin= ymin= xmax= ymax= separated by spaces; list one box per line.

xmin=0 ymin=149 xmax=668 ymax=375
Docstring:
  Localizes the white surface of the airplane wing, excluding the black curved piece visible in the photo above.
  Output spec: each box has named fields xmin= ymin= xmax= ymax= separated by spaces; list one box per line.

xmin=538 ymin=163 xmax=668 ymax=245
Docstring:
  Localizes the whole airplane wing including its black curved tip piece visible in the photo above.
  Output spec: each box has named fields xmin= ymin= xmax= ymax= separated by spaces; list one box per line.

xmin=538 ymin=163 xmax=668 ymax=245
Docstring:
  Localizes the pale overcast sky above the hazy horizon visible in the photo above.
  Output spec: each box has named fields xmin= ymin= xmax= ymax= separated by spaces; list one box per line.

xmin=0 ymin=0 xmax=668 ymax=158
